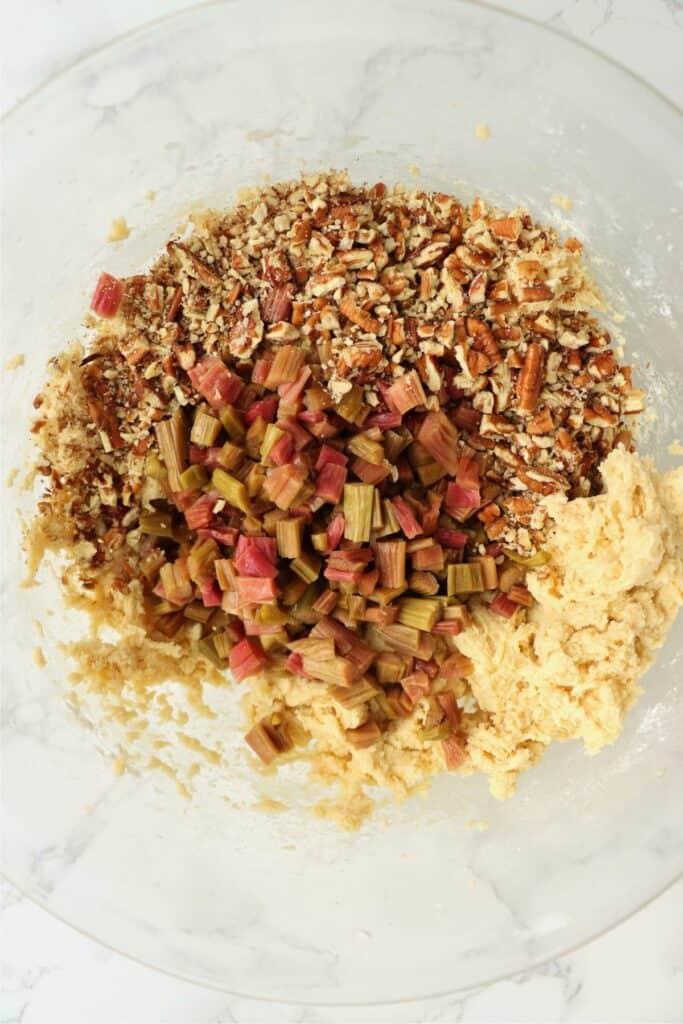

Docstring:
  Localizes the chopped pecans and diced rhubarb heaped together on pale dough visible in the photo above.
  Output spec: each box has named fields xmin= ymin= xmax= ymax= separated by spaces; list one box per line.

xmin=31 ymin=175 xmax=642 ymax=767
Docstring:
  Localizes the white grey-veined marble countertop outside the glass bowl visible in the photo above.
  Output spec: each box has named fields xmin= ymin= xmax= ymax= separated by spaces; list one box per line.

xmin=0 ymin=0 xmax=683 ymax=1024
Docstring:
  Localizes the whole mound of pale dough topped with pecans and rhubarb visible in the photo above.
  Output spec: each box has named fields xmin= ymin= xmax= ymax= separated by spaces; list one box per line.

xmin=29 ymin=172 xmax=683 ymax=825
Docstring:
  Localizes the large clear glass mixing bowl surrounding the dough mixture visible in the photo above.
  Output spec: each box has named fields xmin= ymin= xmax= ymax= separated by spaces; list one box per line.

xmin=2 ymin=0 xmax=683 ymax=1004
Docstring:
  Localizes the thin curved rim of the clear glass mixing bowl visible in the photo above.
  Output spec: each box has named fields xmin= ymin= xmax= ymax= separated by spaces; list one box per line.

xmin=0 ymin=0 xmax=683 ymax=1009
